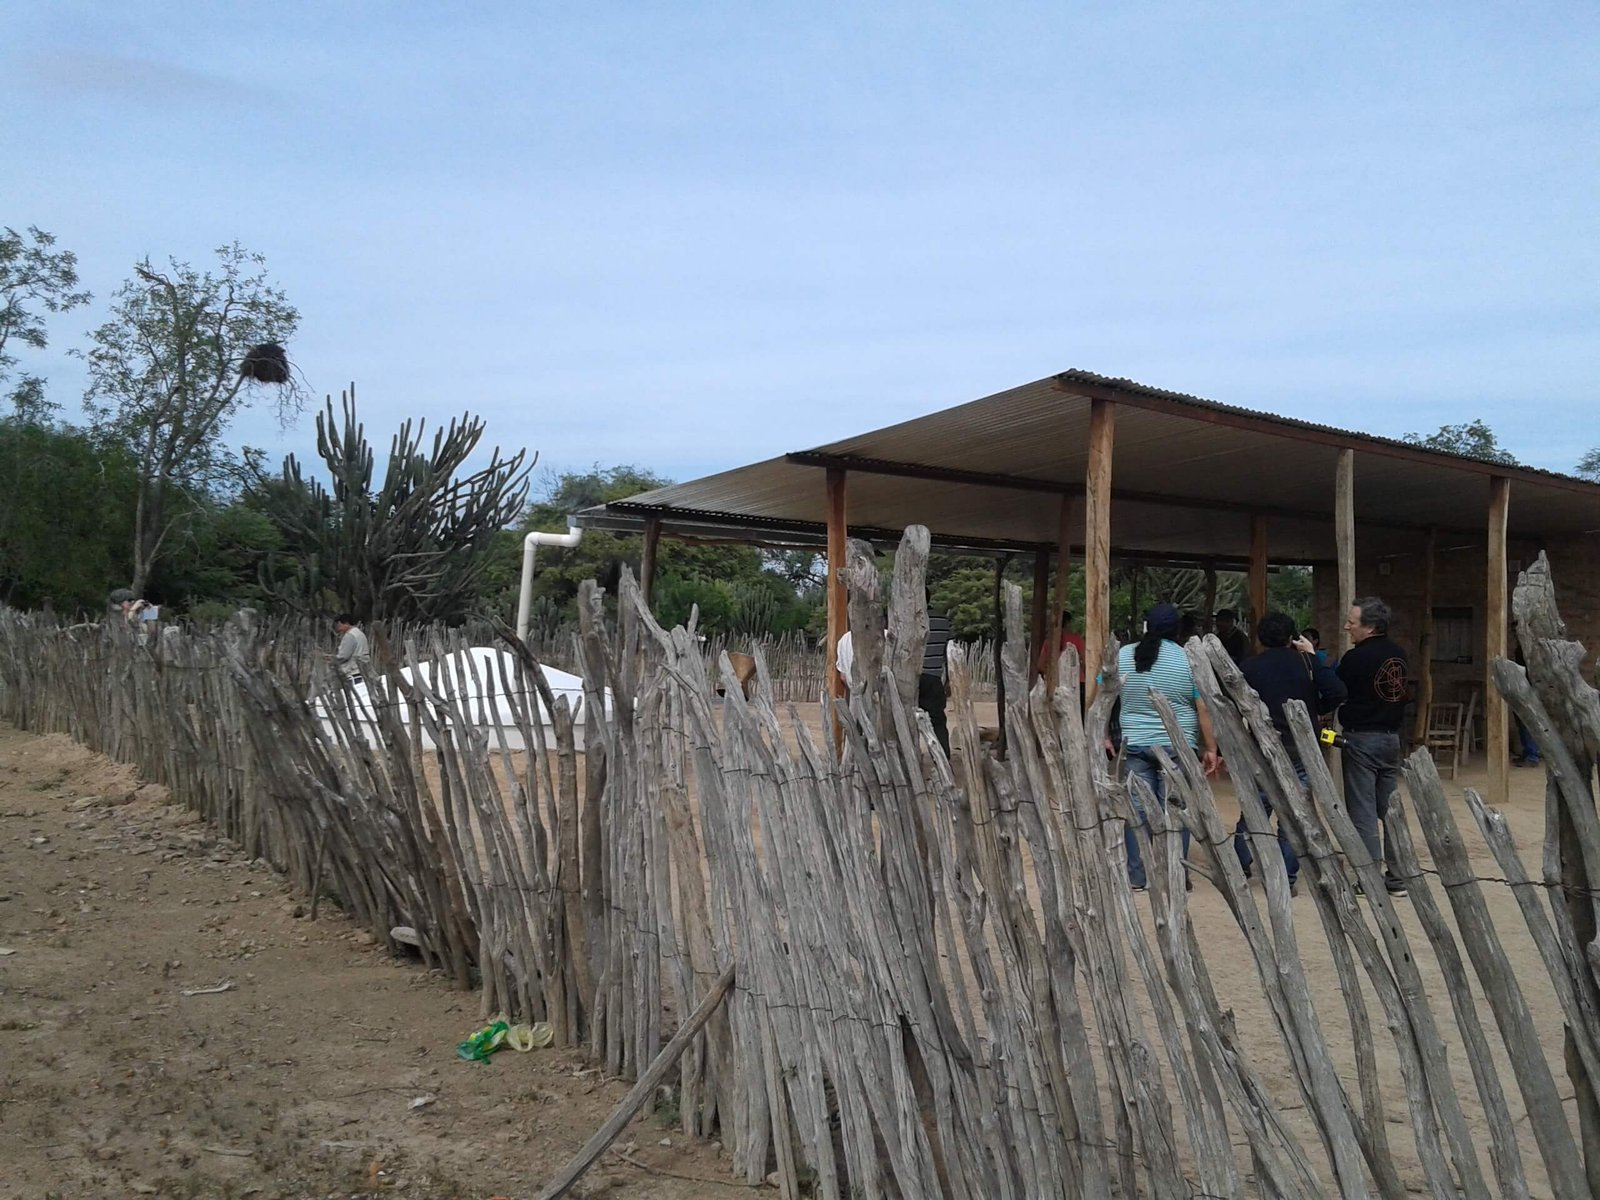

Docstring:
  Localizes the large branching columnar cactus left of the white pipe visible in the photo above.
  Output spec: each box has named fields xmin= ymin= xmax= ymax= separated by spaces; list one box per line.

xmin=251 ymin=394 xmax=533 ymax=622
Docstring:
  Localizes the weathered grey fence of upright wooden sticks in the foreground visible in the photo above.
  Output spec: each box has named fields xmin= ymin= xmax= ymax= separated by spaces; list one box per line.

xmin=0 ymin=544 xmax=1600 ymax=1200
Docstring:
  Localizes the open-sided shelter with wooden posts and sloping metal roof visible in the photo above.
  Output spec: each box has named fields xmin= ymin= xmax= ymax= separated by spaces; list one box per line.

xmin=578 ymin=370 xmax=1600 ymax=798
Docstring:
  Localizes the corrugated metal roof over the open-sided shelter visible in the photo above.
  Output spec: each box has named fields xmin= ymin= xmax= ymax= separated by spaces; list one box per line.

xmin=582 ymin=371 xmax=1600 ymax=562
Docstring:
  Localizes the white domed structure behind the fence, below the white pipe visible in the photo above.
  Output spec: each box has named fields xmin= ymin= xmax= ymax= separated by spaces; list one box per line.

xmin=312 ymin=646 xmax=611 ymax=750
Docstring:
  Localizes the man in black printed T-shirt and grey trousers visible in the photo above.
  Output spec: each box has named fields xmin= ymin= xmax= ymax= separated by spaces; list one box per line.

xmin=1339 ymin=595 xmax=1406 ymax=894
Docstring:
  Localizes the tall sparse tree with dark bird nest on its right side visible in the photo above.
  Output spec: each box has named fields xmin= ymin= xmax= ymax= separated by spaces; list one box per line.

xmin=85 ymin=242 xmax=306 ymax=592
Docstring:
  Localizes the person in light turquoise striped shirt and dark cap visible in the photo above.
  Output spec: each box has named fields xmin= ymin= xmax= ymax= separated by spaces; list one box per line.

xmin=1117 ymin=605 xmax=1219 ymax=891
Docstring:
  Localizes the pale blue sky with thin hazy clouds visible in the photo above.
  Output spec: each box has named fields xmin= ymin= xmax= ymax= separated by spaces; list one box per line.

xmin=0 ymin=0 xmax=1600 ymax=480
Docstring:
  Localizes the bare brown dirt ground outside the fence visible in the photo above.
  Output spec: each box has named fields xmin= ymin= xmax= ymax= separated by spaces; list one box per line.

xmin=0 ymin=725 xmax=752 ymax=1200
